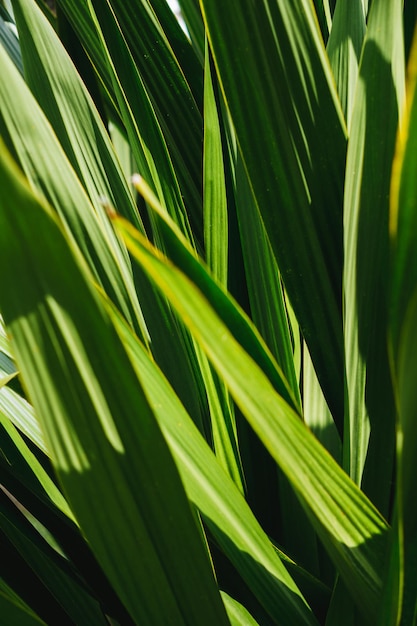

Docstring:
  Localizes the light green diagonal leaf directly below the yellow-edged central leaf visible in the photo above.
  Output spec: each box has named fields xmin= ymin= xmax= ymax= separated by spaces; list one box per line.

xmin=107 ymin=294 xmax=315 ymax=624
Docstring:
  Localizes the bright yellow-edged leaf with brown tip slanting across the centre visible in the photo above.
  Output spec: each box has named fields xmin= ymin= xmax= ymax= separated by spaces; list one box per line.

xmin=116 ymin=212 xmax=388 ymax=620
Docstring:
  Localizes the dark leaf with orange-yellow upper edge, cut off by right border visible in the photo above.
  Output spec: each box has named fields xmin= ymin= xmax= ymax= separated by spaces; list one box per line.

xmin=383 ymin=24 xmax=417 ymax=626
